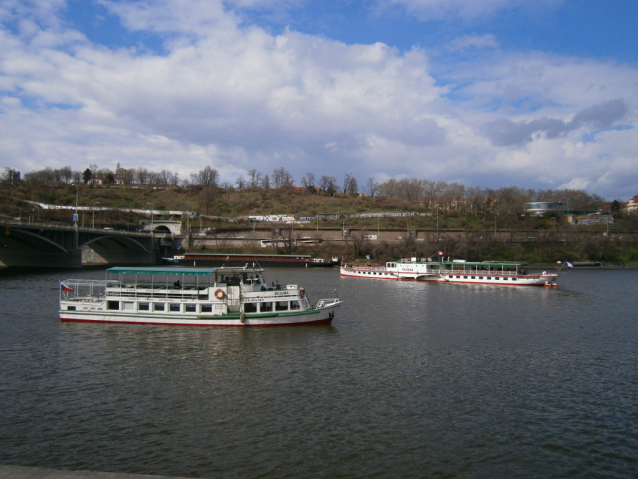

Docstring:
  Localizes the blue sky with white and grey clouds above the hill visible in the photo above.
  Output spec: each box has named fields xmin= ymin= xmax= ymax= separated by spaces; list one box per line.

xmin=0 ymin=0 xmax=638 ymax=200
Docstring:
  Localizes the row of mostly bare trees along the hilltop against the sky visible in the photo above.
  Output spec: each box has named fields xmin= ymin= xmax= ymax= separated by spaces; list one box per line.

xmin=2 ymin=163 xmax=617 ymax=215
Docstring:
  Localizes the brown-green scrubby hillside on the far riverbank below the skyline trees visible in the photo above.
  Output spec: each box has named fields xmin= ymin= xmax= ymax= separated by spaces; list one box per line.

xmin=0 ymin=180 xmax=638 ymax=262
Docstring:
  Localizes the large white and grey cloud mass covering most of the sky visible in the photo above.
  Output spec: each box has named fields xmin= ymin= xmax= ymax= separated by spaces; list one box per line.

xmin=0 ymin=0 xmax=638 ymax=201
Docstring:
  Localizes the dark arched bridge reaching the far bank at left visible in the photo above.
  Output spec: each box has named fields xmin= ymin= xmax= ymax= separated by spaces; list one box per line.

xmin=0 ymin=223 xmax=184 ymax=268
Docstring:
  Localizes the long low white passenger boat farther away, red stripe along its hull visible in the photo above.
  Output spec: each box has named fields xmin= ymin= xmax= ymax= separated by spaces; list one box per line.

xmin=341 ymin=257 xmax=558 ymax=286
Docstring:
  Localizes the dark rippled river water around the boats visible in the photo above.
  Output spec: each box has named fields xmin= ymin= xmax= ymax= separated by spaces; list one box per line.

xmin=0 ymin=268 xmax=638 ymax=478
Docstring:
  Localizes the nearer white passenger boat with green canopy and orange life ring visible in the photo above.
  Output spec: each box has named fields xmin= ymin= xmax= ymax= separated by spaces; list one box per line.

xmin=60 ymin=266 xmax=341 ymax=326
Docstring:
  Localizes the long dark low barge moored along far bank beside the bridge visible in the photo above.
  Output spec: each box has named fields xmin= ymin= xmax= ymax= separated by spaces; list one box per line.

xmin=170 ymin=253 xmax=339 ymax=268
